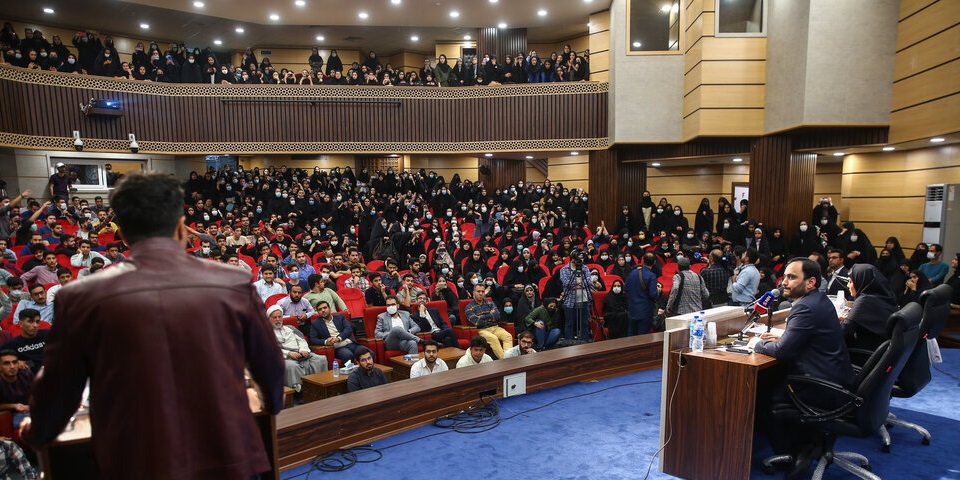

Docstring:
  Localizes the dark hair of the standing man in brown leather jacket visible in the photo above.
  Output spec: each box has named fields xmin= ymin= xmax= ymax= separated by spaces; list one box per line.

xmin=110 ymin=173 xmax=183 ymax=245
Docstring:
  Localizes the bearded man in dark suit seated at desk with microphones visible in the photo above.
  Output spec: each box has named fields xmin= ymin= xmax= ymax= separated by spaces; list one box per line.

xmin=751 ymin=258 xmax=853 ymax=478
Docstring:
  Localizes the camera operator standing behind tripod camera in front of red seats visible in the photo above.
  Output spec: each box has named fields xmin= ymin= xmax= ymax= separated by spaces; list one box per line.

xmin=560 ymin=247 xmax=593 ymax=342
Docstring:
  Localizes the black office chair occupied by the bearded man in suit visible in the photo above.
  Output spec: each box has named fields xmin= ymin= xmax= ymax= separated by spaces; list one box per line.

xmin=763 ymin=303 xmax=923 ymax=480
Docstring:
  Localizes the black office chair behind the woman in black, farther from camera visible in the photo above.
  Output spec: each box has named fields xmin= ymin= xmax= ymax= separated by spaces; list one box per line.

xmin=880 ymin=285 xmax=953 ymax=452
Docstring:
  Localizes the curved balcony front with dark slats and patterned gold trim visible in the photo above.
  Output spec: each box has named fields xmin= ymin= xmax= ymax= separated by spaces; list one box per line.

xmin=0 ymin=65 xmax=609 ymax=154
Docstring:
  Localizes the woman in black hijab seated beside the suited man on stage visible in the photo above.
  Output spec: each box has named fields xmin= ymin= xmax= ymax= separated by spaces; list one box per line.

xmin=841 ymin=263 xmax=897 ymax=350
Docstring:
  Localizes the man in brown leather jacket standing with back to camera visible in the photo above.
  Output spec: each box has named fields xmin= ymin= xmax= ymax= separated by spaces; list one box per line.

xmin=23 ymin=174 xmax=284 ymax=480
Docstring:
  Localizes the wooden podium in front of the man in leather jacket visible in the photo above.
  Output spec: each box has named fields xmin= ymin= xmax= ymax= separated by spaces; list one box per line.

xmin=38 ymin=387 xmax=280 ymax=480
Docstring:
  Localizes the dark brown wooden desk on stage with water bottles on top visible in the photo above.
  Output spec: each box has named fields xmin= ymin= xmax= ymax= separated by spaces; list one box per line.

xmin=660 ymin=307 xmax=787 ymax=479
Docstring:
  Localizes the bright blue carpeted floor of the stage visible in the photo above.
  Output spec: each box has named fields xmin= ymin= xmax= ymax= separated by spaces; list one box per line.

xmin=282 ymin=350 xmax=960 ymax=480
